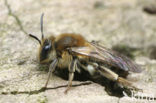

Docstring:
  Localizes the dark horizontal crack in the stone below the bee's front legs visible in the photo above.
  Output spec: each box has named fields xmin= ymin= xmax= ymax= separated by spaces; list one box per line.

xmin=1 ymin=82 xmax=92 ymax=95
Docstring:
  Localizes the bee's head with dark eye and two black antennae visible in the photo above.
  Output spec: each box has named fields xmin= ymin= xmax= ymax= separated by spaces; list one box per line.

xmin=29 ymin=14 xmax=56 ymax=64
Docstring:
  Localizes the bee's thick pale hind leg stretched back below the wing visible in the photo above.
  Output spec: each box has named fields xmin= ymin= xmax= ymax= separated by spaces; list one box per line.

xmin=97 ymin=66 xmax=139 ymax=90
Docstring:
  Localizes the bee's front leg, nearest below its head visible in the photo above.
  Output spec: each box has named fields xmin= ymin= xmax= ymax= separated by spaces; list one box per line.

xmin=44 ymin=59 xmax=58 ymax=88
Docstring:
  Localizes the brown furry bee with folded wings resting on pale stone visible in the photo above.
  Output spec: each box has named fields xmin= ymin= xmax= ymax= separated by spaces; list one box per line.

xmin=29 ymin=14 xmax=141 ymax=93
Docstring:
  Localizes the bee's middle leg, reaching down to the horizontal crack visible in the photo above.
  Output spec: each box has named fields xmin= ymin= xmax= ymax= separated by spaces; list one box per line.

xmin=65 ymin=59 xmax=77 ymax=93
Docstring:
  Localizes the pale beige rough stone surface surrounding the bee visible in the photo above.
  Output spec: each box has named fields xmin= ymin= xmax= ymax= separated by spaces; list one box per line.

xmin=0 ymin=0 xmax=156 ymax=103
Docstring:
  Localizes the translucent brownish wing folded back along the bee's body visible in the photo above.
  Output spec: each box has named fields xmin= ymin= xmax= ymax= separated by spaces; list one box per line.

xmin=70 ymin=42 xmax=141 ymax=73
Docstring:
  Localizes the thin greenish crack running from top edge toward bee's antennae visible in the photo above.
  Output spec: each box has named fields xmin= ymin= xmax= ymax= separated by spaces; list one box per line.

xmin=5 ymin=0 xmax=28 ymax=35
